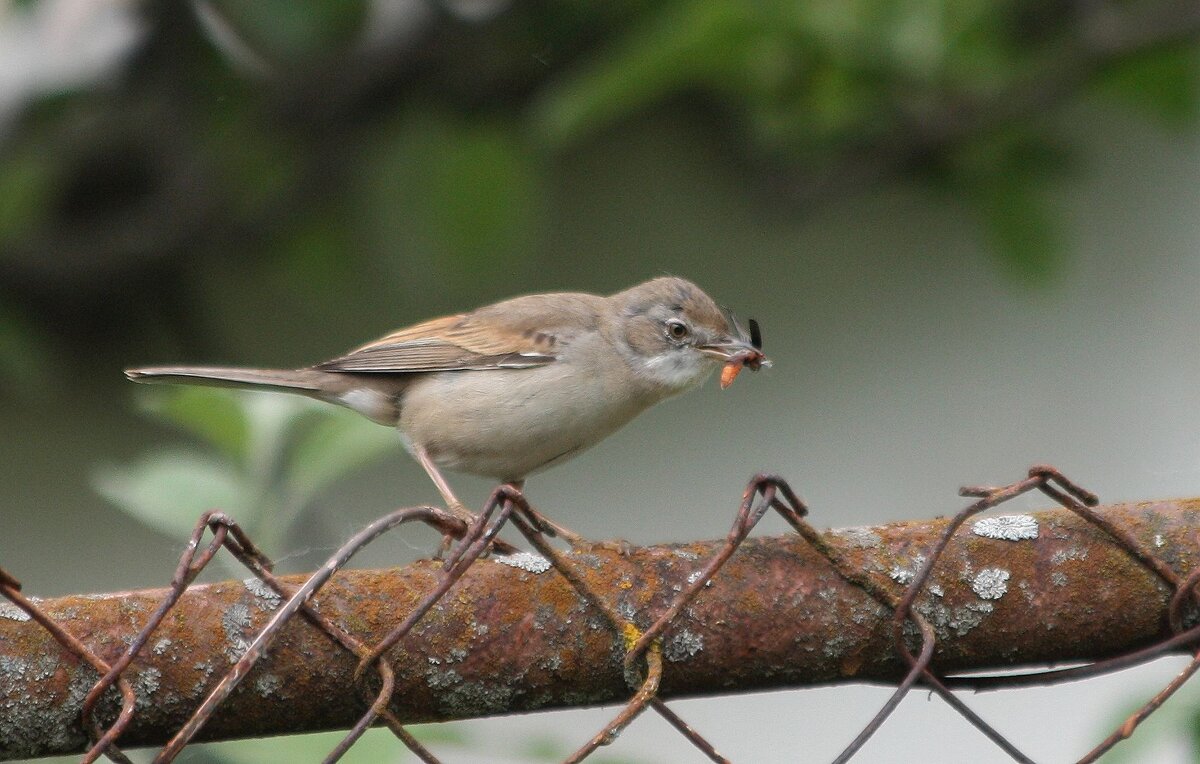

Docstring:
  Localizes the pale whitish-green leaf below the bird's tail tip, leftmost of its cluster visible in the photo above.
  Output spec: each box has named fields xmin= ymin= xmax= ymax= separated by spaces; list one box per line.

xmin=91 ymin=451 xmax=258 ymax=539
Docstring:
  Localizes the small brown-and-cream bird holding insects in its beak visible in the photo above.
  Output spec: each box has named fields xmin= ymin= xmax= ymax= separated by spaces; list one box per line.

xmin=125 ymin=276 xmax=770 ymax=545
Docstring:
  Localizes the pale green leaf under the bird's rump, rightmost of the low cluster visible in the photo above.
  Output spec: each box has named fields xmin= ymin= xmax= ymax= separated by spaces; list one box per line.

xmin=284 ymin=408 xmax=400 ymax=505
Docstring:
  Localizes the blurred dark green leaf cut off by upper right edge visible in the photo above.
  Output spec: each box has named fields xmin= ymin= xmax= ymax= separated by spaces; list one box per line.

xmin=1097 ymin=43 xmax=1200 ymax=127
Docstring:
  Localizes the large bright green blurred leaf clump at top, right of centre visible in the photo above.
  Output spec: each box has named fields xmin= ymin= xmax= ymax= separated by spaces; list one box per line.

xmin=533 ymin=0 xmax=1019 ymax=153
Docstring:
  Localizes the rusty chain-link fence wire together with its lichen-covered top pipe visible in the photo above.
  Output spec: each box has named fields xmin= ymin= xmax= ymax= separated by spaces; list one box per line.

xmin=0 ymin=467 xmax=1200 ymax=762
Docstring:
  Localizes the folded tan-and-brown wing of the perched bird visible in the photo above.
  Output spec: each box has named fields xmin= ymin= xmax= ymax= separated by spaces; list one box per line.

xmin=316 ymin=295 xmax=594 ymax=373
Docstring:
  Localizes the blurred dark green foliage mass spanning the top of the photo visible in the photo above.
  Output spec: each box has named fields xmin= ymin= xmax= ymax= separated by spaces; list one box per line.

xmin=0 ymin=0 xmax=1200 ymax=376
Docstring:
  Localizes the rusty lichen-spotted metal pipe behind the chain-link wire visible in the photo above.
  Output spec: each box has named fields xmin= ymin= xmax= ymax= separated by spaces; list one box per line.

xmin=0 ymin=499 xmax=1200 ymax=759
